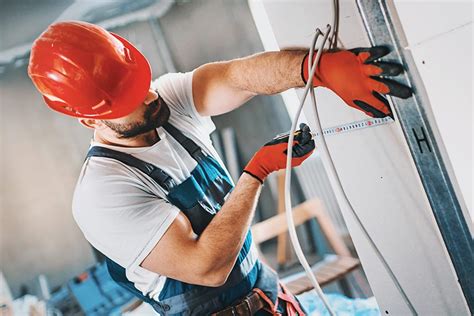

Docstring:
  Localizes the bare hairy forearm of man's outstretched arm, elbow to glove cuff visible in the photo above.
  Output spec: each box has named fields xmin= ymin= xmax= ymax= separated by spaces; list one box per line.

xmin=227 ymin=50 xmax=308 ymax=95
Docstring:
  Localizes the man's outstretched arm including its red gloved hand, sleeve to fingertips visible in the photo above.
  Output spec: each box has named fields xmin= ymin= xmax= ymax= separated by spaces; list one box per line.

xmin=193 ymin=46 xmax=412 ymax=117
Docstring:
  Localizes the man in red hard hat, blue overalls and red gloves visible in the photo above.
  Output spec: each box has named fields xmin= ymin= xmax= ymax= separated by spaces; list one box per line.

xmin=28 ymin=21 xmax=411 ymax=315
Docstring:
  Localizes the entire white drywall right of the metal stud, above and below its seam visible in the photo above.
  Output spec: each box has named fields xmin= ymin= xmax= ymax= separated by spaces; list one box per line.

xmin=394 ymin=1 xmax=474 ymax=220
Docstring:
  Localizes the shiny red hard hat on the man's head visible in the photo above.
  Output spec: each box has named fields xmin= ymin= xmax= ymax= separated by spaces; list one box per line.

xmin=28 ymin=21 xmax=151 ymax=119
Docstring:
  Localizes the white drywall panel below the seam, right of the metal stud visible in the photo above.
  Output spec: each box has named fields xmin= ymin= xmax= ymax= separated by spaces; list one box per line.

xmin=411 ymin=26 xmax=474 ymax=227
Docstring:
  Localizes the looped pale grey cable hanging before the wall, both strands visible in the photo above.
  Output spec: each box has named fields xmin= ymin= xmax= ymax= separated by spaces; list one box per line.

xmin=285 ymin=0 xmax=417 ymax=316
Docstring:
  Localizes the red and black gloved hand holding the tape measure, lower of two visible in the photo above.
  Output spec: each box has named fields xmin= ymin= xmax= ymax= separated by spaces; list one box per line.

xmin=244 ymin=123 xmax=315 ymax=183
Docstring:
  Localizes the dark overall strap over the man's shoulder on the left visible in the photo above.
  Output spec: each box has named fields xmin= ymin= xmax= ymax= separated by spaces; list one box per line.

xmin=87 ymin=146 xmax=176 ymax=191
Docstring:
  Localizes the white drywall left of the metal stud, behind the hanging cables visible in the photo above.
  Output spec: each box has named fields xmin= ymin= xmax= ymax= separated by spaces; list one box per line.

xmin=249 ymin=0 xmax=469 ymax=315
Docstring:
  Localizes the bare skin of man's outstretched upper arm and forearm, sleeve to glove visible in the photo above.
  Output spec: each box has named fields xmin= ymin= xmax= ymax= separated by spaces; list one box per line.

xmin=193 ymin=50 xmax=307 ymax=116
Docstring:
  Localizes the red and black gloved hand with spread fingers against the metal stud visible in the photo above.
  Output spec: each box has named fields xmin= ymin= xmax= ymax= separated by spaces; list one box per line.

xmin=301 ymin=46 xmax=412 ymax=117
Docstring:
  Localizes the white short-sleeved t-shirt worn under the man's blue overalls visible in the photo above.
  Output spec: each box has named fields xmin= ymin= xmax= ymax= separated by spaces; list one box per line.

xmin=72 ymin=72 xmax=230 ymax=299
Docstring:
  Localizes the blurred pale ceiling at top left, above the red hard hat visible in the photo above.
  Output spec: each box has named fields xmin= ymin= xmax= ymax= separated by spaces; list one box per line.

xmin=0 ymin=0 xmax=173 ymax=66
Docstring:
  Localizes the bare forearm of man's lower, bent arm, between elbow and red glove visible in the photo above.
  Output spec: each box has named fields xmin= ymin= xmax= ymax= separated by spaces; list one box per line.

xmin=197 ymin=173 xmax=261 ymax=275
